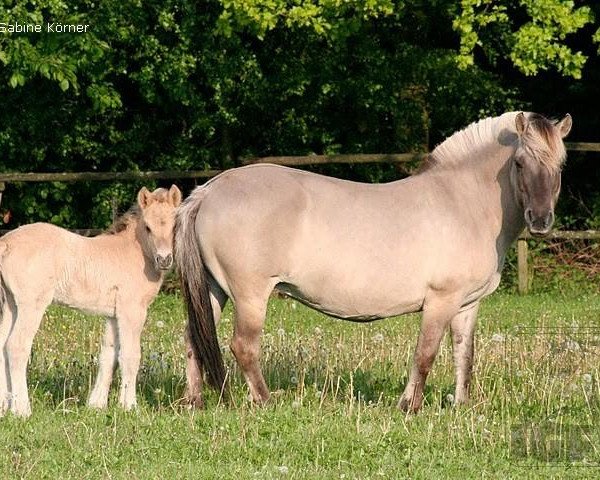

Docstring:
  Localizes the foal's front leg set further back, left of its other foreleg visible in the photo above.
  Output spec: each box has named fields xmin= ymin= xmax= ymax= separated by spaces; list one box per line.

xmin=88 ymin=318 xmax=119 ymax=408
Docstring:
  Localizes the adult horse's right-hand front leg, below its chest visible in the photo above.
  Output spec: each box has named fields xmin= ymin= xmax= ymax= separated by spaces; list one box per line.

xmin=450 ymin=302 xmax=479 ymax=405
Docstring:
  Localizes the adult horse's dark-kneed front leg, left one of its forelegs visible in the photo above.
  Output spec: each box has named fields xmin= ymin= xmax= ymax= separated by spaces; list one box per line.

xmin=398 ymin=296 xmax=459 ymax=412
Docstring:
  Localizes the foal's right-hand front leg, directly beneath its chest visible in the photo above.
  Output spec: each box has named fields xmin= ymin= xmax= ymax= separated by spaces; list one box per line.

xmin=117 ymin=309 xmax=146 ymax=410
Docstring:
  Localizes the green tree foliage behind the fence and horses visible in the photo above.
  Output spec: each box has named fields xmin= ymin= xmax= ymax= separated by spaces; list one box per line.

xmin=0 ymin=0 xmax=600 ymax=227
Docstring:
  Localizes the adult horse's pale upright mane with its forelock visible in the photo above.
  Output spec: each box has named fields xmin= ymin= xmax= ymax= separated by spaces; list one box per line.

xmin=420 ymin=112 xmax=566 ymax=172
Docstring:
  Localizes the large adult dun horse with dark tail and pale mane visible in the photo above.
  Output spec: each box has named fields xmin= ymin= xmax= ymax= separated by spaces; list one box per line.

xmin=175 ymin=112 xmax=572 ymax=411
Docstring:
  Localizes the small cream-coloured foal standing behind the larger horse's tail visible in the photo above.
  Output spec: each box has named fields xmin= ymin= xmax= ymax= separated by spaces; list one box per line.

xmin=0 ymin=185 xmax=181 ymax=416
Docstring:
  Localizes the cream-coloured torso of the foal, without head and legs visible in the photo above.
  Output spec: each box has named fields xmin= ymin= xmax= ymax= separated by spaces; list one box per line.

xmin=0 ymin=223 xmax=149 ymax=316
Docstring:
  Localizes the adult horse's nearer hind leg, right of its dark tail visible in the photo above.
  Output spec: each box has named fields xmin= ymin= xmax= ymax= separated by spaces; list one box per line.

xmin=231 ymin=295 xmax=270 ymax=404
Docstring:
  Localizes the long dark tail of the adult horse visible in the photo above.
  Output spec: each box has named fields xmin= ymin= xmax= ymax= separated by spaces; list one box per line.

xmin=175 ymin=188 xmax=226 ymax=393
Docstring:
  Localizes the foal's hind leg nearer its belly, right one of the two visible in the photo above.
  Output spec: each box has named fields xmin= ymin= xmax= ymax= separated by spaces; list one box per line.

xmin=5 ymin=297 xmax=52 ymax=417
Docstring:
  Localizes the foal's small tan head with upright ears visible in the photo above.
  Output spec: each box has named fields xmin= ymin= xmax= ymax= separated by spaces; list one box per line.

xmin=137 ymin=185 xmax=181 ymax=270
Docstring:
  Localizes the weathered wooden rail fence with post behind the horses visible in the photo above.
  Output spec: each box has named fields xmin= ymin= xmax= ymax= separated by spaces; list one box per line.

xmin=0 ymin=142 xmax=600 ymax=294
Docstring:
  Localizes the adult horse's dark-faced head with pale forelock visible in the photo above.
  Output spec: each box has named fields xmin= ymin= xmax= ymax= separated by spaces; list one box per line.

xmin=511 ymin=112 xmax=573 ymax=236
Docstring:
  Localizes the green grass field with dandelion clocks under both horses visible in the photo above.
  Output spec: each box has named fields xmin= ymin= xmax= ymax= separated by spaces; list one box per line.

xmin=0 ymin=290 xmax=600 ymax=480
